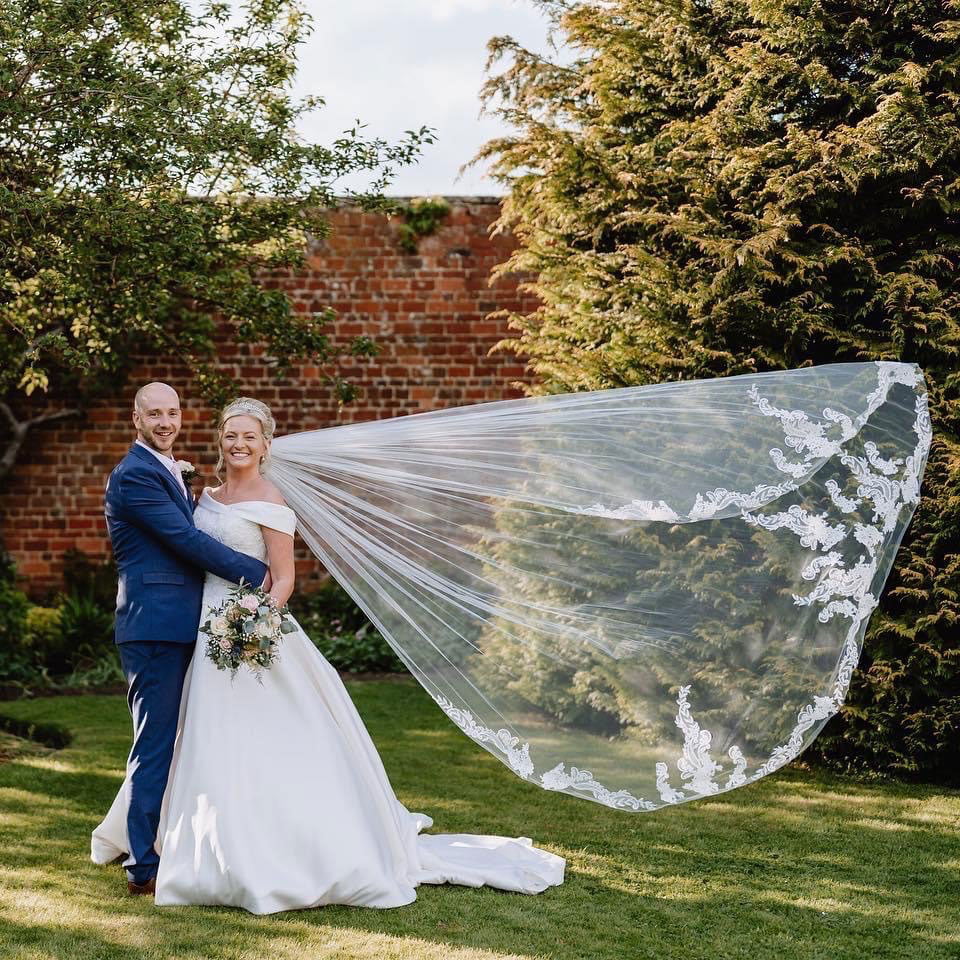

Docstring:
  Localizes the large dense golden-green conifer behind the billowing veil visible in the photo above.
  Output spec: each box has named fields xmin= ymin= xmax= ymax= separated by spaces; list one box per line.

xmin=474 ymin=0 xmax=960 ymax=777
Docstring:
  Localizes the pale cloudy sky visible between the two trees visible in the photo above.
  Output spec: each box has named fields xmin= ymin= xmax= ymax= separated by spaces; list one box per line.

xmin=293 ymin=0 xmax=560 ymax=196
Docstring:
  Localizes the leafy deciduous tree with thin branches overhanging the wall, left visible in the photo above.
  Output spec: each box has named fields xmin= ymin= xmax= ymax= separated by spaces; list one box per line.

xmin=0 ymin=0 xmax=432 ymax=478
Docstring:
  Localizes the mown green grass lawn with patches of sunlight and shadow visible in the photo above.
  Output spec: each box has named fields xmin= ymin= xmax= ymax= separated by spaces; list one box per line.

xmin=0 ymin=681 xmax=960 ymax=960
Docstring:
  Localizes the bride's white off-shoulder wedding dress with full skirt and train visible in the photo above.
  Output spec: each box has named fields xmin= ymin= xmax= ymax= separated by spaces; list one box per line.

xmin=91 ymin=490 xmax=565 ymax=914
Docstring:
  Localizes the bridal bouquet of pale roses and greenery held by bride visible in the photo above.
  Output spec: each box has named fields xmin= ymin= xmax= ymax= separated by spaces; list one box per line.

xmin=200 ymin=581 xmax=297 ymax=683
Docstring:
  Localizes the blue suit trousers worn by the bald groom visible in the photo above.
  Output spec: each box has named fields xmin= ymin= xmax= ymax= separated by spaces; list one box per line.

xmin=117 ymin=641 xmax=194 ymax=884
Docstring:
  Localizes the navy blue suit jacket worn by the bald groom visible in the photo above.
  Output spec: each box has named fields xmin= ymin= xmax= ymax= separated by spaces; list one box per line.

xmin=104 ymin=444 xmax=267 ymax=643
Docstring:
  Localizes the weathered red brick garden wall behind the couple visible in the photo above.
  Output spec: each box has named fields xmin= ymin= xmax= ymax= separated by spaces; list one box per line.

xmin=0 ymin=197 xmax=536 ymax=596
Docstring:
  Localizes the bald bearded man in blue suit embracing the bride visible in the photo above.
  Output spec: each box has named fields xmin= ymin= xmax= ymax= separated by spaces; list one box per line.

xmin=104 ymin=383 xmax=267 ymax=894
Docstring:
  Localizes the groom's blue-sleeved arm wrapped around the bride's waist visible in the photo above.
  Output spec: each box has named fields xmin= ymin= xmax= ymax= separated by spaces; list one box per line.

xmin=114 ymin=471 xmax=267 ymax=587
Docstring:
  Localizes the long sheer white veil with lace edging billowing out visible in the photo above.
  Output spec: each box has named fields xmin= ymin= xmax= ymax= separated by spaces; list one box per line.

xmin=270 ymin=362 xmax=931 ymax=811
